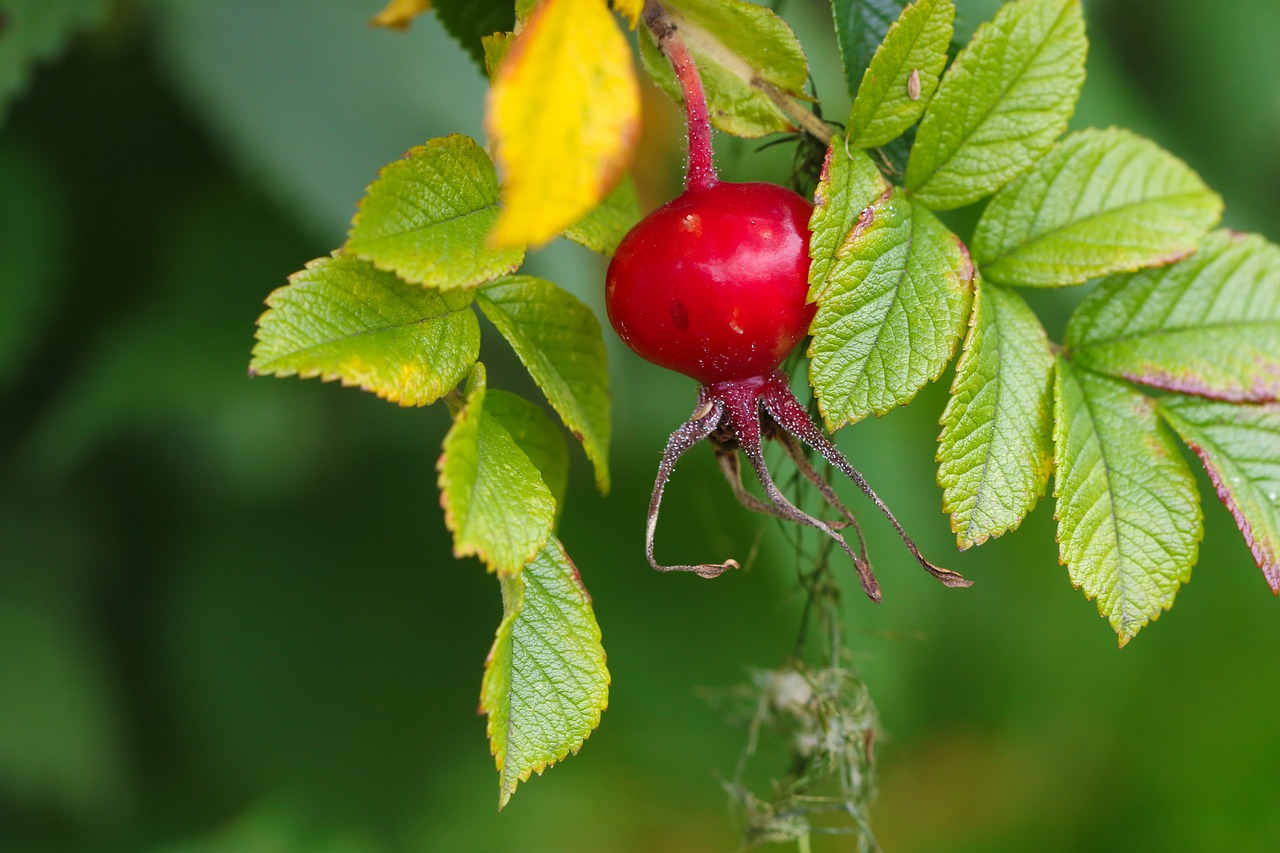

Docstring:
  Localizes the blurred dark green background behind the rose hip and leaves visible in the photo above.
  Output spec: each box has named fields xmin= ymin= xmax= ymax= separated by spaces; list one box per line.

xmin=0 ymin=0 xmax=1280 ymax=853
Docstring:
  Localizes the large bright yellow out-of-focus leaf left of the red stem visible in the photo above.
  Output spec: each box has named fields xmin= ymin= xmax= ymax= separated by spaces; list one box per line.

xmin=485 ymin=0 xmax=640 ymax=246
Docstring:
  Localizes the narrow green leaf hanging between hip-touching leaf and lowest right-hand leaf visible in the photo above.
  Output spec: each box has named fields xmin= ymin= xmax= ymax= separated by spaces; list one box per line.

xmin=938 ymin=280 xmax=1053 ymax=549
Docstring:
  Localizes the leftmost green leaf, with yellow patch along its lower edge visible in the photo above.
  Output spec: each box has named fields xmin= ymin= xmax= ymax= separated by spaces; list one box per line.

xmin=250 ymin=255 xmax=480 ymax=406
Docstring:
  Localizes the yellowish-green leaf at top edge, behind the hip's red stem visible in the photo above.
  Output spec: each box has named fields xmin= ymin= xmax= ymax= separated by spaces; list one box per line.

xmin=640 ymin=0 xmax=809 ymax=138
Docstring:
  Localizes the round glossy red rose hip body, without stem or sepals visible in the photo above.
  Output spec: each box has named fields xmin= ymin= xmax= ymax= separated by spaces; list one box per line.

xmin=605 ymin=183 xmax=817 ymax=384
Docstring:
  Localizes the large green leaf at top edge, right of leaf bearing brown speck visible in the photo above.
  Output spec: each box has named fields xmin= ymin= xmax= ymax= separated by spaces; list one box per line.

xmin=906 ymin=0 xmax=1088 ymax=210
